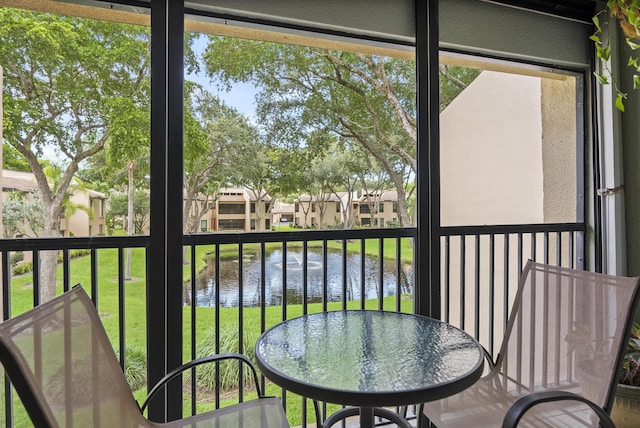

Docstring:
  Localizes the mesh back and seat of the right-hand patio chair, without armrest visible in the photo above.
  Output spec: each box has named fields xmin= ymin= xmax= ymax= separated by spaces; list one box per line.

xmin=423 ymin=262 xmax=639 ymax=428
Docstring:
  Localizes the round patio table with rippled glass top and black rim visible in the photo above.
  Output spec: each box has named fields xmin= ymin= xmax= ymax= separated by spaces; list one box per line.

xmin=256 ymin=310 xmax=484 ymax=428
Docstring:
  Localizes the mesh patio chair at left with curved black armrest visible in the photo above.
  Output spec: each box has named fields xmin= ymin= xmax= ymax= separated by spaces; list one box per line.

xmin=0 ymin=286 xmax=289 ymax=428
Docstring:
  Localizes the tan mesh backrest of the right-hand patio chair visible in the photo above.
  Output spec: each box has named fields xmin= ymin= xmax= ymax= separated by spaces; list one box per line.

xmin=494 ymin=262 xmax=640 ymax=411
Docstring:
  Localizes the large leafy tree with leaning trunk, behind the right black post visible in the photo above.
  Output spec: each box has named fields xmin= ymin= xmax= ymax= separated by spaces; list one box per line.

xmin=204 ymin=36 xmax=477 ymax=226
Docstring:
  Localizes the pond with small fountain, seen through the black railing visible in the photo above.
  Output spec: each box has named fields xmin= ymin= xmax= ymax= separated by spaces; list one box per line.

xmin=184 ymin=248 xmax=413 ymax=307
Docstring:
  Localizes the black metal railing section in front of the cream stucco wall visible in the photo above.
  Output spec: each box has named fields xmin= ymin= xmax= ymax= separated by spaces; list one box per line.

xmin=441 ymin=223 xmax=586 ymax=356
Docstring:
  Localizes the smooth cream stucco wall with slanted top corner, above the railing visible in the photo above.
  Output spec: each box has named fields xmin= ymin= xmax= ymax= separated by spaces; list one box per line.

xmin=440 ymin=71 xmax=544 ymax=226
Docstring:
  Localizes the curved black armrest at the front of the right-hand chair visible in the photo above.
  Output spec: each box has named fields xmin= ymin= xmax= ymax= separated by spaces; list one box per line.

xmin=502 ymin=391 xmax=615 ymax=428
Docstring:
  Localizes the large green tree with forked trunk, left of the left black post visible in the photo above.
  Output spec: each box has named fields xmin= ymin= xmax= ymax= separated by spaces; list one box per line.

xmin=0 ymin=8 xmax=149 ymax=301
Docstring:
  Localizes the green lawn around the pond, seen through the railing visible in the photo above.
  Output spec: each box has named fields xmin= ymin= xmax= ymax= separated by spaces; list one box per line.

xmin=2 ymin=232 xmax=412 ymax=426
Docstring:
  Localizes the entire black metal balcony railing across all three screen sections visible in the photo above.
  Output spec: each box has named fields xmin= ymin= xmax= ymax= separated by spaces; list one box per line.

xmin=1 ymin=224 xmax=585 ymax=426
